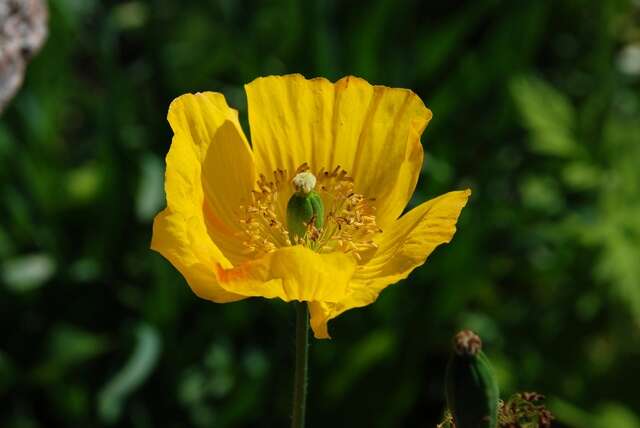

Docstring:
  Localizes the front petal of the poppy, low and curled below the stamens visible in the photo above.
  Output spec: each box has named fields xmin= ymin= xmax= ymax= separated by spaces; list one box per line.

xmin=218 ymin=245 xmax=356 ymax=302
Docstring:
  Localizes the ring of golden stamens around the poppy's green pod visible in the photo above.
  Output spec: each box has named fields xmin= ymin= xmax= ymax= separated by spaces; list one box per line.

xmin=240 ymin=163 xmax=382 ymax=260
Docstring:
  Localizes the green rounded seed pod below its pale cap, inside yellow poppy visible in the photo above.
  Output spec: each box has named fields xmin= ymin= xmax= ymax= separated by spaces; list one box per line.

xmin=287 ymin=191 xmax=324 ymax=241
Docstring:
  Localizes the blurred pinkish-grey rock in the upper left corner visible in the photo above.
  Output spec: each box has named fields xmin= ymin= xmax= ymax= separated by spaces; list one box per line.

xmin=0 ymin=0 xmax=47 ymax=113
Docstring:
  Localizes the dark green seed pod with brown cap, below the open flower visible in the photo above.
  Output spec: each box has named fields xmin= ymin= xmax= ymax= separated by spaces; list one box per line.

xmin=445 ymin=330 xmax=500 ymax=428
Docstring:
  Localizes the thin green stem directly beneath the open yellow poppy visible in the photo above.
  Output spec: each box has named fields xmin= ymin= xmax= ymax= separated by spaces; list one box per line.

xmin=291 ymin=302 xmax=309 ymax=428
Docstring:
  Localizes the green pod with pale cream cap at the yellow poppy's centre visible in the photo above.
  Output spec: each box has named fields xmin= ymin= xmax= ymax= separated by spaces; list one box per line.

xmin=287 ymin=172 xmax=324 ymax=242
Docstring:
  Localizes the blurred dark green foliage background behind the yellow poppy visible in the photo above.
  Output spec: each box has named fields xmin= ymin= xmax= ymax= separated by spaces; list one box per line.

xmin=0 ymin=0 xmax=640 ymax=428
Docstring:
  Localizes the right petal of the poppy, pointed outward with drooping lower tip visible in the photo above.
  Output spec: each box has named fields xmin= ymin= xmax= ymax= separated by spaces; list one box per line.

xmin=309 ymin=190 xmax=471 ymax=339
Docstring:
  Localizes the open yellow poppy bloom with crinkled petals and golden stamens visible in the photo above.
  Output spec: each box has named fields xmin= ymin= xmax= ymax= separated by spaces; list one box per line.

xmin=151 ymin=75 xmax=470 ymax=338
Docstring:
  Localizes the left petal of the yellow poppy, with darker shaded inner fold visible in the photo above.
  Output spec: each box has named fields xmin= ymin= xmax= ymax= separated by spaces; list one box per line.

xmin=151 ymin=93 xmax=255 ymax=303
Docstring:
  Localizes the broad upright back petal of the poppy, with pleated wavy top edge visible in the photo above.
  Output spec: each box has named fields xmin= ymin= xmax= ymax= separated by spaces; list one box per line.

xmin=245 ymin=74 xmax=431 ymax=229
